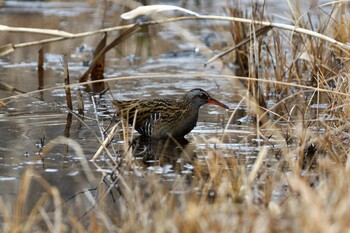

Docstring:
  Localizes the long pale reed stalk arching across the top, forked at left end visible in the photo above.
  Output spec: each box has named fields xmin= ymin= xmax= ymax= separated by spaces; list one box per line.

xmin=0 ymin=15 xmax=350 ymax=56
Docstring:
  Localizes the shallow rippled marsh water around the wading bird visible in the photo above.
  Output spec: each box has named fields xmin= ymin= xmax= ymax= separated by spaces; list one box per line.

xmin=0 ymin=1 xmax=330 ymax=217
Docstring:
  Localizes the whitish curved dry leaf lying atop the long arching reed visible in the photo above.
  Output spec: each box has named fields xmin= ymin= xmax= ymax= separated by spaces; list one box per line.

xmin=120 ymin=5 xmax=199 ymax=19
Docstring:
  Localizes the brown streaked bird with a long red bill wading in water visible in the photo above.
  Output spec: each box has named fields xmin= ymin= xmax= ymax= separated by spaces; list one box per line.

xmin=112 ymin=88 xmax=229 ymax=138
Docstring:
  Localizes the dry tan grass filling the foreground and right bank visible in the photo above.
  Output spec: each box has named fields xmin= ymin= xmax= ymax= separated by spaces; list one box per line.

xmin=0 ymin=2 xmax=350 ymax=233
